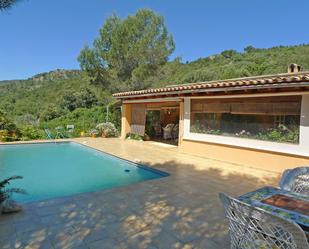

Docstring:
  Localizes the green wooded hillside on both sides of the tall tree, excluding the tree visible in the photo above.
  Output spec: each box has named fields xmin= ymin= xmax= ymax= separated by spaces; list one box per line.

xmin=0 ymin=45 xmax=309 ymax=139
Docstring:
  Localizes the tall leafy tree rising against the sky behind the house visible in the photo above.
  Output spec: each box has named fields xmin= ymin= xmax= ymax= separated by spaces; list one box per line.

xmin=78 ymin=9 xmax=175 ymax=92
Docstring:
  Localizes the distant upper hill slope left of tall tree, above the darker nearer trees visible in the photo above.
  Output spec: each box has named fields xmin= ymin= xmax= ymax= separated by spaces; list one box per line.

xmin=0 ymin=70 xmax=110 ymax=119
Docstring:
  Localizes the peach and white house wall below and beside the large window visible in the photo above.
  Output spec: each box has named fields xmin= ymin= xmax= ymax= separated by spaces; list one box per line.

xmin=180 ymin=94 xmax=309 ymax=173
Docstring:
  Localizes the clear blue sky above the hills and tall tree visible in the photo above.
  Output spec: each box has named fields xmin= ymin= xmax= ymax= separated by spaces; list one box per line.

xmin=0 ymin=0 xmax=309 ymax=80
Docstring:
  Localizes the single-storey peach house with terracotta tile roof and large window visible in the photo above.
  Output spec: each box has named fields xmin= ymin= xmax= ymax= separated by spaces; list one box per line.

xmin=113 ymin=64 xmax=309 ymax=172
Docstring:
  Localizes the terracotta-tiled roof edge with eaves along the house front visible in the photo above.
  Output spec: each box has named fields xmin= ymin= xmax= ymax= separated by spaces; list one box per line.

xmin=113 ymin=72 xmax=309 ymax=100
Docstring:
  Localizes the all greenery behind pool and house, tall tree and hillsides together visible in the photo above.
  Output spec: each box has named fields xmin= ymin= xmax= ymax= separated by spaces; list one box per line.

xmin=0 ymin=10 xmax=309 ymax=141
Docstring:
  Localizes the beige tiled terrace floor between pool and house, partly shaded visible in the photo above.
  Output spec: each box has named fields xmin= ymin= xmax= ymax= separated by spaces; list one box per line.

xmin=0 ymin=139 xmax=279 ymax=249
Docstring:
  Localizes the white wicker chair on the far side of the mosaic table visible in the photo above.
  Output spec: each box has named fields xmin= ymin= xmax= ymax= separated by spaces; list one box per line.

xmin=279 ymin=167 xmax=309 ymax=196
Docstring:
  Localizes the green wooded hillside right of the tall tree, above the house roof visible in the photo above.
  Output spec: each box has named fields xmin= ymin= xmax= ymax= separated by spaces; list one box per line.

xmin=148 ymin=45 xmax=309 ymax=86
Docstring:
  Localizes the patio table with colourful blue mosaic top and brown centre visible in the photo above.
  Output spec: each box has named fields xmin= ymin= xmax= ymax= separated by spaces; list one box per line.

xmin=238 ymin=187 xmax=309 ymax=233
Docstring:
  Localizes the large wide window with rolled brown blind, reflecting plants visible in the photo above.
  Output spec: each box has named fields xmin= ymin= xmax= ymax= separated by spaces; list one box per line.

xmin=190 ymin=96 xmax=301 ymax=144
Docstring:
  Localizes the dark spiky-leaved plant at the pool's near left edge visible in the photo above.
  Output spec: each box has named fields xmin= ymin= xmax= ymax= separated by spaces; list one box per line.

xmin=0 ymin=176 xmax=26 ymax=213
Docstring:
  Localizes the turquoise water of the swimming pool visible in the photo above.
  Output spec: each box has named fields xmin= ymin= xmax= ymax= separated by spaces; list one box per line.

xmin=0 ymin=142 xmax=167 ymax=202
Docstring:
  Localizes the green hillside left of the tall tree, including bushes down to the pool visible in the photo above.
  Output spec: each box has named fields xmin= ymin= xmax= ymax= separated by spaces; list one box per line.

xmin=0 ymin=70 xmax=120 ymax=141
